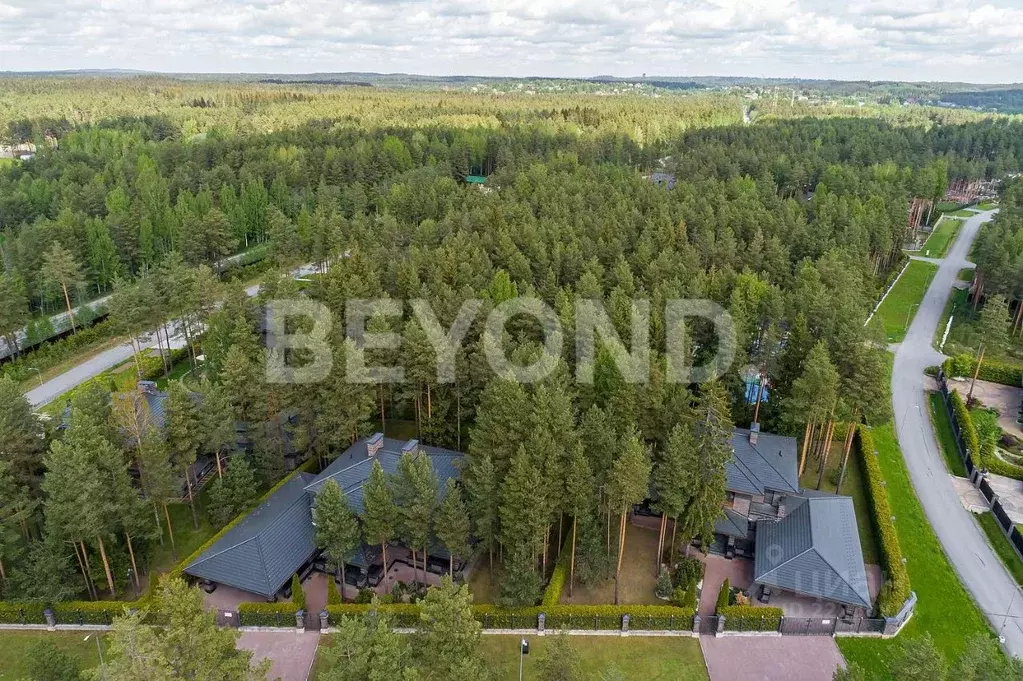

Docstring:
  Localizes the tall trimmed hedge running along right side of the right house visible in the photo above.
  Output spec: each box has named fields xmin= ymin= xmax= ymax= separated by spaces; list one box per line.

xmin=856 ymin=425 xmax=909 ymax=618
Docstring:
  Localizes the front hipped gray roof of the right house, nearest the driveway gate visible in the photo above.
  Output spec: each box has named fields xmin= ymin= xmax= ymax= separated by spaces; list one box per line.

xmin=753 ymin=495 xmax=871 ymax=608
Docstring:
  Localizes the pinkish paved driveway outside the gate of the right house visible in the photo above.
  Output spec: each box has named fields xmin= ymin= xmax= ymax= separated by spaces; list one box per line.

xmin=700 ymin=636 xmax=845 ymax=681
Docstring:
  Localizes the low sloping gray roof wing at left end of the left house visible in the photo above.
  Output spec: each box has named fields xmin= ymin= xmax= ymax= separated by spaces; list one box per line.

xmin=184 ymin=473 xmax=316 ymax=598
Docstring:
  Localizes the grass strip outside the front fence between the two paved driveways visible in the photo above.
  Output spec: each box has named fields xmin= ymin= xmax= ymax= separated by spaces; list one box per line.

xmin=309 ymin=635 xmax=708 ymax=681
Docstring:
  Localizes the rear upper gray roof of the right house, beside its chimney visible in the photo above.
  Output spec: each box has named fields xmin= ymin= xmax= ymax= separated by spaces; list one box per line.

xmin=725 ymin=428 xmax=799 ymax=494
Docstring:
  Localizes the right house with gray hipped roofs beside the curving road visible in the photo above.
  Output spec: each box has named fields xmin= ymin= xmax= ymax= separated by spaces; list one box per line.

xmin=710 ymin=423 xmax=871 ymax=610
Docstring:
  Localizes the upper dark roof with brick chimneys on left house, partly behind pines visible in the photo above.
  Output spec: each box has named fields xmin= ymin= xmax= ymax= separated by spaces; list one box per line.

xmin=306 ymin=438 xmax=462 ymax=513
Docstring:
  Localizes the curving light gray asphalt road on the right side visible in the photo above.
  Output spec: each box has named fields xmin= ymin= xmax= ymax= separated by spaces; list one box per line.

xmin=892 ymin=206 xmax=1023 ymax=655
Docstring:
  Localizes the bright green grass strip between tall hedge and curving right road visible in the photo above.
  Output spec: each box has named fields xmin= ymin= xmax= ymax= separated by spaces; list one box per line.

xmin=838 ymin=423 xmax=991 ymax=679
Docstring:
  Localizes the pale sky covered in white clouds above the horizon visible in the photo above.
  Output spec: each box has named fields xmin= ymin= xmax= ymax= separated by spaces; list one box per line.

xmin=0 ymin=0 xmax=1023 ymax=83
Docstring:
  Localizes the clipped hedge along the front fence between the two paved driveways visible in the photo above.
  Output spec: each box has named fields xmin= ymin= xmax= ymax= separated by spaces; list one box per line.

xmin=326 ymin=603 xmax=696 ymax=631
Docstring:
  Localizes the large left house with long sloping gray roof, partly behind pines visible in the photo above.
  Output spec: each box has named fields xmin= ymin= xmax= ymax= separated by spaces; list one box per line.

xmin=184 ymin=433 xmax=462 ymax=600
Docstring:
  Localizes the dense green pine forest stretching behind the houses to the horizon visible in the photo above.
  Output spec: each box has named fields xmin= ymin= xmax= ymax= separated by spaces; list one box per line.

xmin=0 ymin=79 xmax=1023 ymax=604
